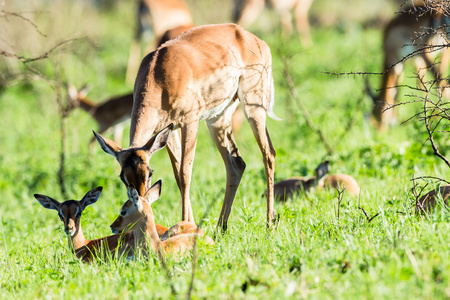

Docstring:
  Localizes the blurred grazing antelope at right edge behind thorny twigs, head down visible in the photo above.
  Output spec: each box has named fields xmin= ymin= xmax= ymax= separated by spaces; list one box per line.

xmin=367 ymin=3 xmax=450 ymax=129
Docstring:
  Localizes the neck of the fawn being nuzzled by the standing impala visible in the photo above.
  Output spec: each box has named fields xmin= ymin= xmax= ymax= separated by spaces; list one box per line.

xmin=134 ymin=203 xmax=160 ymax=250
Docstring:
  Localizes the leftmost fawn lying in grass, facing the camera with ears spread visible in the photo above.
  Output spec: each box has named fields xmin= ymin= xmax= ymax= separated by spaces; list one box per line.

xmin=34 ymin=187 xmax=168 ymax=262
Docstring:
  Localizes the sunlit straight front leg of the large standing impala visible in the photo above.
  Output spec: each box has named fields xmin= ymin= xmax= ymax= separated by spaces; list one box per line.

xmin=180 ymin=121 xmax=198 ymax=222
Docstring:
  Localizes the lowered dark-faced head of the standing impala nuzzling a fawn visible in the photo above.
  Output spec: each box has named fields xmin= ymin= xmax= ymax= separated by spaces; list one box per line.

xmin=94 ymin=124 xmax=173 ymax=196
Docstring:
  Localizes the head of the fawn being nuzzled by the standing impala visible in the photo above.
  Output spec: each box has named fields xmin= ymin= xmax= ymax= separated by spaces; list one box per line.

xmin=110 ymin=180 xmax=162 ymax=234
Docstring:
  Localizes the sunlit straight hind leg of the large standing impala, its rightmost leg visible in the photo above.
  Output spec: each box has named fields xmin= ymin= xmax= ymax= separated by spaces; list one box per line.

xmin=245 ymin=106 xmax=276 ymax=226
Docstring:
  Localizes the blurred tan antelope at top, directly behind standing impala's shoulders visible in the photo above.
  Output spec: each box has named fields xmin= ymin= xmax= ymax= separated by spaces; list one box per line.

xmin=126 ymin=0 xmax=193 ymax=82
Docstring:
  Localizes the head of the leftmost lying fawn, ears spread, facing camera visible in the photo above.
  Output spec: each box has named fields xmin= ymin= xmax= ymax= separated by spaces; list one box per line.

xmin=34 ymin=186 xmax=103 ymax=237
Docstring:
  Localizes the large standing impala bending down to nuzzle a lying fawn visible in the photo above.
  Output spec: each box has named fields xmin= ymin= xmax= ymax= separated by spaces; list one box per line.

xmin=94 ymin=24 xmax=276 ymax=229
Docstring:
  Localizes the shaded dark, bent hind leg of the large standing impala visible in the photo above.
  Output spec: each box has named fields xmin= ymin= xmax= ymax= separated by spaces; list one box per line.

xmin=206 ymin=114 xmax=245 ymax=231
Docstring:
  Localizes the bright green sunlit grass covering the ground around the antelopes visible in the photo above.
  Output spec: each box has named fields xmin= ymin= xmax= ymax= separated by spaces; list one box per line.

xmin=0 ymin=1 xmax=450 ymax=299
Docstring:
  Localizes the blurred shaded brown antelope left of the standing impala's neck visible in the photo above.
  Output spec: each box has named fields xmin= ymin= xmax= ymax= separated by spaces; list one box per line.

xmin=67 ymin=85 xmax=133 ymax=145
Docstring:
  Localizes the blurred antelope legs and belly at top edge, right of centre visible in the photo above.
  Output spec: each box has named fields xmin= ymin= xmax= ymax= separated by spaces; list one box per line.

xmin=233 ymin=0 xmax=313 ymax=47
